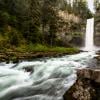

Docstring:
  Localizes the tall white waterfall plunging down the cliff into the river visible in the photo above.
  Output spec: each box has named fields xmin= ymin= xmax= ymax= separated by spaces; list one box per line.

xmin=85 ymin=18 xmax=94 ymax=51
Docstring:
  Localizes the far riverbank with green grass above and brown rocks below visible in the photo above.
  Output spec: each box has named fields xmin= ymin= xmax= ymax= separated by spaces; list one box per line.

xmin=0 ymin=44 xmax=80 ymax=63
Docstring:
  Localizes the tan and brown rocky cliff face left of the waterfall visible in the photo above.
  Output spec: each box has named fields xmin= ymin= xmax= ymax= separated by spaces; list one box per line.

xmin=57 ymin=10 xmax=85 ymax=46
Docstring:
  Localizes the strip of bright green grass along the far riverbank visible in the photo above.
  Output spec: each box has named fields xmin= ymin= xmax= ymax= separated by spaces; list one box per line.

xmin=16 ymin=44 xmax=79 ymax=53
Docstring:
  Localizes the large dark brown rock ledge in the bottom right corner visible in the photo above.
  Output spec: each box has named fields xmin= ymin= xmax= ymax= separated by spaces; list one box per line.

xmin=64 ymin=68 xmax=100 ymax=100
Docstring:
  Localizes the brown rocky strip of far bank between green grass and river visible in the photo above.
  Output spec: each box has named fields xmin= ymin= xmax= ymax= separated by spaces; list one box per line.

xmin=0 ymin=50 xmax=80 ymax=63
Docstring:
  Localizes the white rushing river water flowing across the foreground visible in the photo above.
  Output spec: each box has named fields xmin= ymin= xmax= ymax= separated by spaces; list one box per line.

xmin=0 ymin=52 xmax=95 ymax=100
